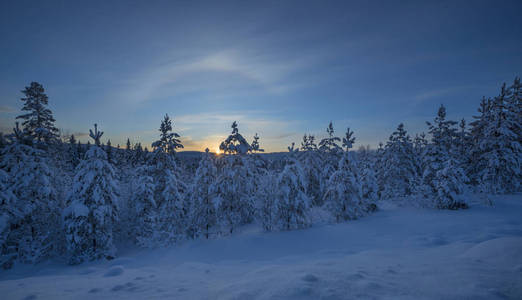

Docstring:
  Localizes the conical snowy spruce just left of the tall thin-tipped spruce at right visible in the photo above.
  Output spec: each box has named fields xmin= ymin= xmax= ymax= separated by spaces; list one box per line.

xmin=381 ymin=123 xmax=417 ymax=198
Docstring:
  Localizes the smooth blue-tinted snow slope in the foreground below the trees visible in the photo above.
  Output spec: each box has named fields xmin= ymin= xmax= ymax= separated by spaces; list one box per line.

xmin=0 ymin=195 xmax=522 ymax=299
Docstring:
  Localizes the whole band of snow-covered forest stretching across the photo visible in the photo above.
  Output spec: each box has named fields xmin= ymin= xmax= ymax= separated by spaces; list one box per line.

xmin=0 ymin=78 xmax=522 ymax=269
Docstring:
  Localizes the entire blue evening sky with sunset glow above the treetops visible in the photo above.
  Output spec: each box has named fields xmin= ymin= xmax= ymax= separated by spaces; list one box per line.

xmin=0 ymin=0 xmax=522 ymax=152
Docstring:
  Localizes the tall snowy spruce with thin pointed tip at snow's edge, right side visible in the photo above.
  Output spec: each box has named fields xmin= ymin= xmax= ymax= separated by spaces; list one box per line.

xmin=423 ymin=105 xmax=467 ymax=209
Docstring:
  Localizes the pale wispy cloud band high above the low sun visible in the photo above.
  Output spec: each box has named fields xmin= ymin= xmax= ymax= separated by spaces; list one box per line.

xmin=109 ymin=44 xmax=319 ymax=103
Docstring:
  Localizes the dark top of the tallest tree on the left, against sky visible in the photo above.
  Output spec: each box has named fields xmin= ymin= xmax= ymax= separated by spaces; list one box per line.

xmin=16 ymin=82 xmax=58 ymax=143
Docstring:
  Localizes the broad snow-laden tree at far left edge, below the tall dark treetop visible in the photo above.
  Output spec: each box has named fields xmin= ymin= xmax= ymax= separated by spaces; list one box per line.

xmin=0 ymin=138 xmax=60 ymax=268
